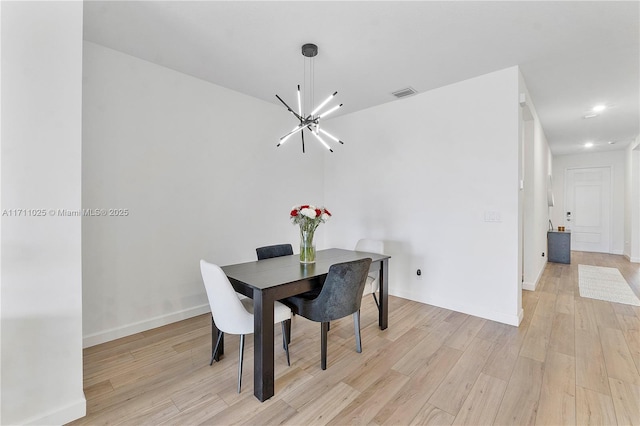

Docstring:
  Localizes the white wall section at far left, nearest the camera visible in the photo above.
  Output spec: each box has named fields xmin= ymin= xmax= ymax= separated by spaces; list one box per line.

xmin=0 ymin=1 xmax=86 ymax=425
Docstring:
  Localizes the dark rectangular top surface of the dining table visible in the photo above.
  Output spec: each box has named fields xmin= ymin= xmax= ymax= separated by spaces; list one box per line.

xmin=222 ymin=248 xmax=391 ymax=289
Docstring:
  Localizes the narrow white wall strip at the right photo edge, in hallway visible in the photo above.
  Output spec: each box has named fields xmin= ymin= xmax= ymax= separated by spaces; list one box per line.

xmin=624 ymin=136 xmax=640 ymax=263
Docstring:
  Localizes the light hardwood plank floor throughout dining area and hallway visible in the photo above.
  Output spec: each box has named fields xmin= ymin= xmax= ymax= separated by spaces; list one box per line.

xmin=72 ymin=252 xmax=640 ymax=425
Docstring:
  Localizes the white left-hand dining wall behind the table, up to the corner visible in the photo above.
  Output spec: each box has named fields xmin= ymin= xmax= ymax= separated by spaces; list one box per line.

xmin=82 ymin=42 xmax=332 ymax=346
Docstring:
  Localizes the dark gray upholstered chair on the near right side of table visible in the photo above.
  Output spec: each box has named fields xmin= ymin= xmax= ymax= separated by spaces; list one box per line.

xmin=282 ymin=258 xmax=371 ymax=370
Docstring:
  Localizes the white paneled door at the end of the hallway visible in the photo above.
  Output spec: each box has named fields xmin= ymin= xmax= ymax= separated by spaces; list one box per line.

xmin=564 ymin=167 xmax=611 ymax=253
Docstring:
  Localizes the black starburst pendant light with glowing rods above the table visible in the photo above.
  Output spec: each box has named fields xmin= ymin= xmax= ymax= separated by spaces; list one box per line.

xmin=276 ymin=43 xmax=344 ymax=153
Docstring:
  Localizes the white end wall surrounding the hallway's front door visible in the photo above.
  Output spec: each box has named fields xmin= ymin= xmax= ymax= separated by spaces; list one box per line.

xmin=551 ymin=150 xmax=625 ymax=254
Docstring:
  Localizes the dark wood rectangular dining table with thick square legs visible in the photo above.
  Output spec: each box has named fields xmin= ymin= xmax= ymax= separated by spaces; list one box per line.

xmin=220 ymin=248 xmax=390 ymax=401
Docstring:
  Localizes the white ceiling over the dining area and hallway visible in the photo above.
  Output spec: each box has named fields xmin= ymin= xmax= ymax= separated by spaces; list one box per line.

xmin=84 ymin=1 xmax=640 ymax=154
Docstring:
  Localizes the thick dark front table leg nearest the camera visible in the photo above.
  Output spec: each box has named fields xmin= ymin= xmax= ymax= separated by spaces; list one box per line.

xmin=253 ymin=290 xmax=275 ymax=402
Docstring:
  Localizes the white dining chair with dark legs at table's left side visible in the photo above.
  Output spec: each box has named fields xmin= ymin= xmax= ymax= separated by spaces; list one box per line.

xmin=200 ymin=260 xmax=291 ymax=393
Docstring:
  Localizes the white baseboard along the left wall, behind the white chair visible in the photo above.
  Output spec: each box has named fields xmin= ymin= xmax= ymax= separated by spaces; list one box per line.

xmin=82 ymin=304 xmax=211 ymax=348
